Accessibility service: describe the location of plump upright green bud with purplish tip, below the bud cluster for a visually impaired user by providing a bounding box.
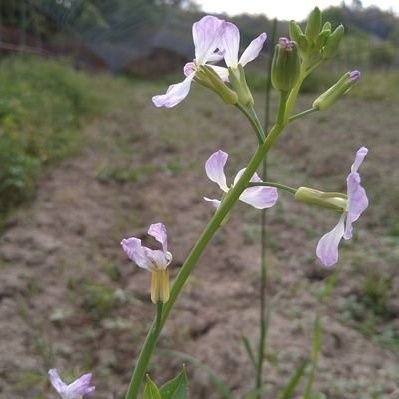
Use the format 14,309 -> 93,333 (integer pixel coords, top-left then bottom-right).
271,37 -> 301,91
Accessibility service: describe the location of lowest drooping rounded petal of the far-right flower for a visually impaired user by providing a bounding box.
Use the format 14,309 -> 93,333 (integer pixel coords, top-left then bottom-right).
316,213 -> 345,266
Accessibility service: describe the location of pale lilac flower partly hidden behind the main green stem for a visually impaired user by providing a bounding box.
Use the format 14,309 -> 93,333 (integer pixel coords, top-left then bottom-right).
204,150 -> 278,209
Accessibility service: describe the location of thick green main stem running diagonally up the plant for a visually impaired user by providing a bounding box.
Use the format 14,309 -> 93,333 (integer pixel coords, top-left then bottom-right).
125,93 -> 287,399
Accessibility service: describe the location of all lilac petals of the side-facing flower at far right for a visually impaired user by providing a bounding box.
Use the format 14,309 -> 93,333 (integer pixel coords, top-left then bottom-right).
316,147 -> 369,266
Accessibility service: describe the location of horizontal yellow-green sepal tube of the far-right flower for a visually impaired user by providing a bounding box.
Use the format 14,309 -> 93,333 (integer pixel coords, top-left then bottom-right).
295,187 -> 348,212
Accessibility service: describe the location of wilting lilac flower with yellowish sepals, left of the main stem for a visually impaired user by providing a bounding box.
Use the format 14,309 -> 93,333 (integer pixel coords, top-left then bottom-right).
121,223 -> 172,304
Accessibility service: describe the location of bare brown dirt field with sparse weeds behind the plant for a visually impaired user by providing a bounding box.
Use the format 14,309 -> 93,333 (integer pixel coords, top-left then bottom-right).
0,79 -> 399,399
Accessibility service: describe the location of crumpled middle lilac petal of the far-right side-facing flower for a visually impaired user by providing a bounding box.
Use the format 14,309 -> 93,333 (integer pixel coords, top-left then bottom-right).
344,172 -> 369,240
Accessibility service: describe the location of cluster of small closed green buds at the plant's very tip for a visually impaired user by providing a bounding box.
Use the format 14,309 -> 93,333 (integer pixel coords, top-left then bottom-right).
289,7 -> 344,60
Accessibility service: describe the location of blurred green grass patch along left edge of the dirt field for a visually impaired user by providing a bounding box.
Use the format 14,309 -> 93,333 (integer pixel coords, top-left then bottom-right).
0,57 -> 101,219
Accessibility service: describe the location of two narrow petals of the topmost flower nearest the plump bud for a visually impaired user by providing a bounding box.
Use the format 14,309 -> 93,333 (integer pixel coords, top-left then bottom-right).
220,22 -> 267,69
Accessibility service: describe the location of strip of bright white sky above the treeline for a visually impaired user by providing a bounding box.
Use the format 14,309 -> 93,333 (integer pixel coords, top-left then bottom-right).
195,0 -> 399,21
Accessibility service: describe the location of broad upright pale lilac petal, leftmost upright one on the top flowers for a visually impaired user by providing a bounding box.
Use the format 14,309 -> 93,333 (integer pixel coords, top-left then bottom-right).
193,15 -> 224,65
